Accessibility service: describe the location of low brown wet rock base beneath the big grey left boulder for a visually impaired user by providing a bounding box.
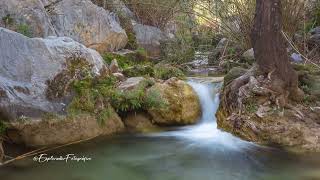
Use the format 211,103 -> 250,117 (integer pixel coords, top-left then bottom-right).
9,112 -> 124,147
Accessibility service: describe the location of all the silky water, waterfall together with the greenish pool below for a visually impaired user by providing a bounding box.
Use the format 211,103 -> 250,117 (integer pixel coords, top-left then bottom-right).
0,80 -> 320,180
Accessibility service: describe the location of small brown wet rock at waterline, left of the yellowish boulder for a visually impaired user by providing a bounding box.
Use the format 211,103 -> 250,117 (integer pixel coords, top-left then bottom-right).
124,112 -> 159,133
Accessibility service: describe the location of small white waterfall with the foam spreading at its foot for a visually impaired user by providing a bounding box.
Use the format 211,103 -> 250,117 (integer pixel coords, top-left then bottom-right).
147,80 -> 253,152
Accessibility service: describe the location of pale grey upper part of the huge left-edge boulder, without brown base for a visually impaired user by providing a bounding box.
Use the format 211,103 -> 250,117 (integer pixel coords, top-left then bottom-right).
0,28 -> 104,119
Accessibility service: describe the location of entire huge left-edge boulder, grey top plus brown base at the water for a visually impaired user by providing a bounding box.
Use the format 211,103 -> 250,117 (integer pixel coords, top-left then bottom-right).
0,28 -> 124,146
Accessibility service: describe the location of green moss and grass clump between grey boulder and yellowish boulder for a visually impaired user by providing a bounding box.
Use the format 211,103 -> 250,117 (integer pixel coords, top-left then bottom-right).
68,76 -> 164,124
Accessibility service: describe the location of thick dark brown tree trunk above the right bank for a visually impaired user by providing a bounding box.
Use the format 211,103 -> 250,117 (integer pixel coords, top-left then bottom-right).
251,0 -> 301,100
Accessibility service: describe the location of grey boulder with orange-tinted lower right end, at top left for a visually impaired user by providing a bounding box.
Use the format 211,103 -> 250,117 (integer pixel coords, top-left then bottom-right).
48,0 -> 128,52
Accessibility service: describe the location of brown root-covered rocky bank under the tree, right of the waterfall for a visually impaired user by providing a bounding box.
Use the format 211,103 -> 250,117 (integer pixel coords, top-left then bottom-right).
216,69 -> 320,152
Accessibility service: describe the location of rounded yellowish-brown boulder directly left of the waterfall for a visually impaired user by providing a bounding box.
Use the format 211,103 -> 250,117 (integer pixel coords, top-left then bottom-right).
148,78 -> 201,125
